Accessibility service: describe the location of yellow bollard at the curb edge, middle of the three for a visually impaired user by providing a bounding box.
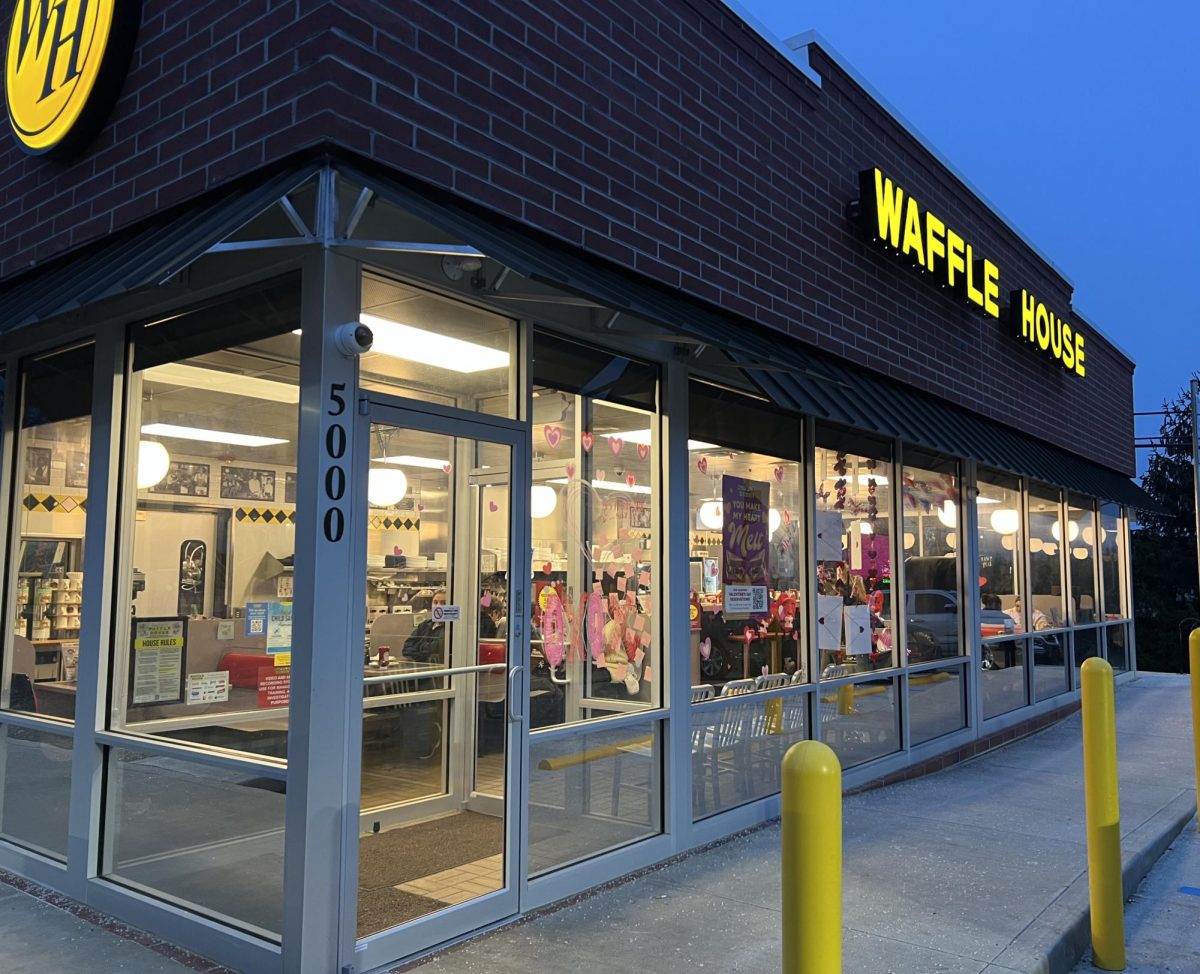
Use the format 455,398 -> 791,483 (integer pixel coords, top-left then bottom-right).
1080,656 -> 1124,970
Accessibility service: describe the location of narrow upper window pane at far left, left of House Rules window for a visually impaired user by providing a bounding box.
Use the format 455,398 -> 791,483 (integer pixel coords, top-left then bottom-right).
0,344 -> 95,719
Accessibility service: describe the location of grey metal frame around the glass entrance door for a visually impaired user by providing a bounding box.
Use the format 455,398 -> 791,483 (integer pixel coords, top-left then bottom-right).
340,391 -> 532,972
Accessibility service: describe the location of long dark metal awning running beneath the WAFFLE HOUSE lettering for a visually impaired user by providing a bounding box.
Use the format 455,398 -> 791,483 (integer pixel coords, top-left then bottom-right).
340,159 -> 1159,511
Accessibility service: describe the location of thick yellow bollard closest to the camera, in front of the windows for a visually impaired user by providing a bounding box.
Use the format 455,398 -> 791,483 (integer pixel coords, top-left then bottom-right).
782,740 -> 841,974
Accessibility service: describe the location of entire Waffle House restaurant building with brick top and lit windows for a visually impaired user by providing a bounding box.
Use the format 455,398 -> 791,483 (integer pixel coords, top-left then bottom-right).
0,0 -> 1144,973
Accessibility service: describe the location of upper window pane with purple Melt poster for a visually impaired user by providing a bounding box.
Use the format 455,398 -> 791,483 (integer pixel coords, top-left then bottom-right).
688,383 -> 808,691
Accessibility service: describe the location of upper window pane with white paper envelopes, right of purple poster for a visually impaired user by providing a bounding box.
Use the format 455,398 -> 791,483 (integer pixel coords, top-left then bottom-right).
812,431 -> 892,679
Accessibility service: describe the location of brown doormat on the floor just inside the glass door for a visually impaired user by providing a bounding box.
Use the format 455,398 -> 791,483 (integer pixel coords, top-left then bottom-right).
359,812 -> 504,892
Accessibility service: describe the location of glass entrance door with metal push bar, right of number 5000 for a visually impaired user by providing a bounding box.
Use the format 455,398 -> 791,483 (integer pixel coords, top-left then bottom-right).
350,403 -> 529,969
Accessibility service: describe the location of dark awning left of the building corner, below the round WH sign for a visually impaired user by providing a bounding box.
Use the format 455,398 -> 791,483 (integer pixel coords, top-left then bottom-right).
0,162 -> 322,335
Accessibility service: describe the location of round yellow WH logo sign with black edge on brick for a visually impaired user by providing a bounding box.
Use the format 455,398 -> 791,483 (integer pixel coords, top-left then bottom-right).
4,0 -> 142,156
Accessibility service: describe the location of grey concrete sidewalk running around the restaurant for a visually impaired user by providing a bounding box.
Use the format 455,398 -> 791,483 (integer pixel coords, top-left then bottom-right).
0,674 -> 1200,974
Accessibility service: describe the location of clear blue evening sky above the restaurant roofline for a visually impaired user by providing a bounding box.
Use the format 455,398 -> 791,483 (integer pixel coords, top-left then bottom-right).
740,0 -> 1200,469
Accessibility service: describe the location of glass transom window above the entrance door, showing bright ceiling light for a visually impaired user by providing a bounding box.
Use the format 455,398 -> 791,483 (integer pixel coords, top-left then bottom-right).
359,273 -> 516,417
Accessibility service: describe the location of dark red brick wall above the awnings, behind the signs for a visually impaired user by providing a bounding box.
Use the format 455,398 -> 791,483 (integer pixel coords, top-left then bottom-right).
0,0 -> 1134,473
